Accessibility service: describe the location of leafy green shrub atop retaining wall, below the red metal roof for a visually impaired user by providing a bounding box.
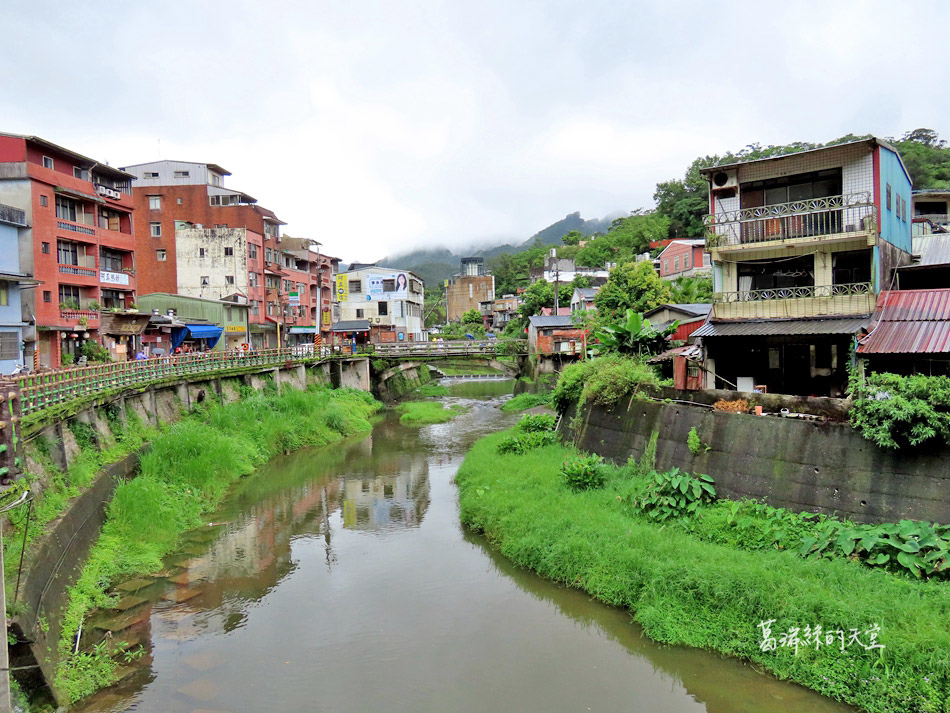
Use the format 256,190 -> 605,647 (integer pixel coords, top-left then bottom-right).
850,374 -> 950,448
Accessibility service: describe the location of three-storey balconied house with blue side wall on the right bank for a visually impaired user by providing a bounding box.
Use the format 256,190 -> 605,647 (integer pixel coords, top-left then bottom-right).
693,138 -> 911,395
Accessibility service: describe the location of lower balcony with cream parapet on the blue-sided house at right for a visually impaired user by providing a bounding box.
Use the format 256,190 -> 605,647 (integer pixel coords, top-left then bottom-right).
712,282 -> 875,320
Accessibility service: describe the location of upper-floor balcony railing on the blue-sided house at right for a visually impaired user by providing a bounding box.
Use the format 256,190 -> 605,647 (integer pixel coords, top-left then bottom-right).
703,191 -> 874,248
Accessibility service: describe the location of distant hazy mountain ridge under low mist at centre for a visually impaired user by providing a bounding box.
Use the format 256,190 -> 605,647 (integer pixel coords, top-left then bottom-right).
377,212 -> 626,286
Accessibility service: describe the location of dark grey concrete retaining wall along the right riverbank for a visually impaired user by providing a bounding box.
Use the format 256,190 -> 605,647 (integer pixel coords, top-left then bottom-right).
561,399 -> 950,523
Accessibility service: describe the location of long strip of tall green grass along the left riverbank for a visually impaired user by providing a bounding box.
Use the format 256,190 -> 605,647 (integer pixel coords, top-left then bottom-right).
56,387 -> 380,702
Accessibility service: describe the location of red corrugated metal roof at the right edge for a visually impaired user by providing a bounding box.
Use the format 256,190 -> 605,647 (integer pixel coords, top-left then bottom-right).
858,289 -> 950,354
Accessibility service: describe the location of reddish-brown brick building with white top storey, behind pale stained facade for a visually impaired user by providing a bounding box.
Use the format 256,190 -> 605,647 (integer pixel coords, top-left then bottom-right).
118,161 -> 284,348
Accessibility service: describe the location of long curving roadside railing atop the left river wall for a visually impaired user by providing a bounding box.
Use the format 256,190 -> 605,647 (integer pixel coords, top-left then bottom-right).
12,344 -> 372,416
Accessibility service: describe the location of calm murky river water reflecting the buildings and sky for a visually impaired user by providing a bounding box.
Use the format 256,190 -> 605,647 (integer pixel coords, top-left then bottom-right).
76,380 -> 851,713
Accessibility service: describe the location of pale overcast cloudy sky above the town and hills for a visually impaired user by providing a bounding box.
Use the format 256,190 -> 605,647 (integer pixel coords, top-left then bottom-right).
0,0 -> 950,261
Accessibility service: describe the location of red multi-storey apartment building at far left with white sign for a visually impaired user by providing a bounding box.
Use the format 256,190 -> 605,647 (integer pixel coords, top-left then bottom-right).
0,134 -> 137,367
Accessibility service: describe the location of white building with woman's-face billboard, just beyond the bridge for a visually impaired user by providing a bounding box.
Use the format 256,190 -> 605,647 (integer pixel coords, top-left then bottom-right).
334,265 -> 425,342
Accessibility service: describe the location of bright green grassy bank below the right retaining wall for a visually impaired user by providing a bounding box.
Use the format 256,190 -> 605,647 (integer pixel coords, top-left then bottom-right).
457,432 -> 950,713
